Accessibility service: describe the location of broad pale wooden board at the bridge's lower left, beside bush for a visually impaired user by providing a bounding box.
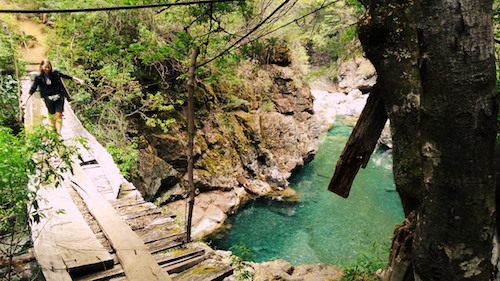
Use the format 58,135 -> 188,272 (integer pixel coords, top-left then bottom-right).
32,179 -> 113,280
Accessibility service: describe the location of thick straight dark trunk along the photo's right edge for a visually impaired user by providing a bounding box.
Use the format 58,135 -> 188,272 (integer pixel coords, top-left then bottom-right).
413,0 -> 497,280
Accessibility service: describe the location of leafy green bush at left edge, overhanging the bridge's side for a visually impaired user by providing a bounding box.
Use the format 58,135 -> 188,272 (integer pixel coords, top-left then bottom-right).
0,126 -> 80,280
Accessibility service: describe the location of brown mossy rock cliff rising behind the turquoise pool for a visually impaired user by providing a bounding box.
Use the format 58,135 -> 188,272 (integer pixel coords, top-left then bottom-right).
133,52 -> 320,236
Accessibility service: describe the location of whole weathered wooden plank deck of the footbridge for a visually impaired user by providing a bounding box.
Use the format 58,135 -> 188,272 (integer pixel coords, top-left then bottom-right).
18,75 -> 232,281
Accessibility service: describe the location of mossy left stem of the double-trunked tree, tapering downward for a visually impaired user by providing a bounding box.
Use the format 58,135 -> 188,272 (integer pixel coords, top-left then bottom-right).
359,0 -> 422,215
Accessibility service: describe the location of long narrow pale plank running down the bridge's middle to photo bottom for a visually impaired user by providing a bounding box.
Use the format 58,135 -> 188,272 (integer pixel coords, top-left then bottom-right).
71,161 -> 171,281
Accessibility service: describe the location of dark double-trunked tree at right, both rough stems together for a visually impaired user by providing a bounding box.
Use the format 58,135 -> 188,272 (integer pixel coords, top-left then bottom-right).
360,0 -> 498,281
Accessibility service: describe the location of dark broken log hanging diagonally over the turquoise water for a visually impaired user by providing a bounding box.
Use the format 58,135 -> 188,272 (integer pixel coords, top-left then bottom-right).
328,85 -> 387,198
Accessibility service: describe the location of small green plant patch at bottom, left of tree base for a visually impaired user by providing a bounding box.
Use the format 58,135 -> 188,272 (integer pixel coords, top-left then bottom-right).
341,243 -> 387,281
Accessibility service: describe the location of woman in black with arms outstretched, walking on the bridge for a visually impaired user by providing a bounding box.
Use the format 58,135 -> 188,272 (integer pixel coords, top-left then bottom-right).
23,59 -> 84,134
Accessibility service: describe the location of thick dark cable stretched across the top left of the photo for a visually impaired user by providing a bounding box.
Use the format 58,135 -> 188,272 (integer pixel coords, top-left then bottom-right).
0,0 -> 242,14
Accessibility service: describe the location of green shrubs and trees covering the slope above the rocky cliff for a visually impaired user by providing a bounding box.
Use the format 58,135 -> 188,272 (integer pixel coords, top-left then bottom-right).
2,0 -> 361,179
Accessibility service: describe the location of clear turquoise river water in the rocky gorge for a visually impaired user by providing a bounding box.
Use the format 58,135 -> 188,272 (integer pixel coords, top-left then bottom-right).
209,118 -> 404,265
